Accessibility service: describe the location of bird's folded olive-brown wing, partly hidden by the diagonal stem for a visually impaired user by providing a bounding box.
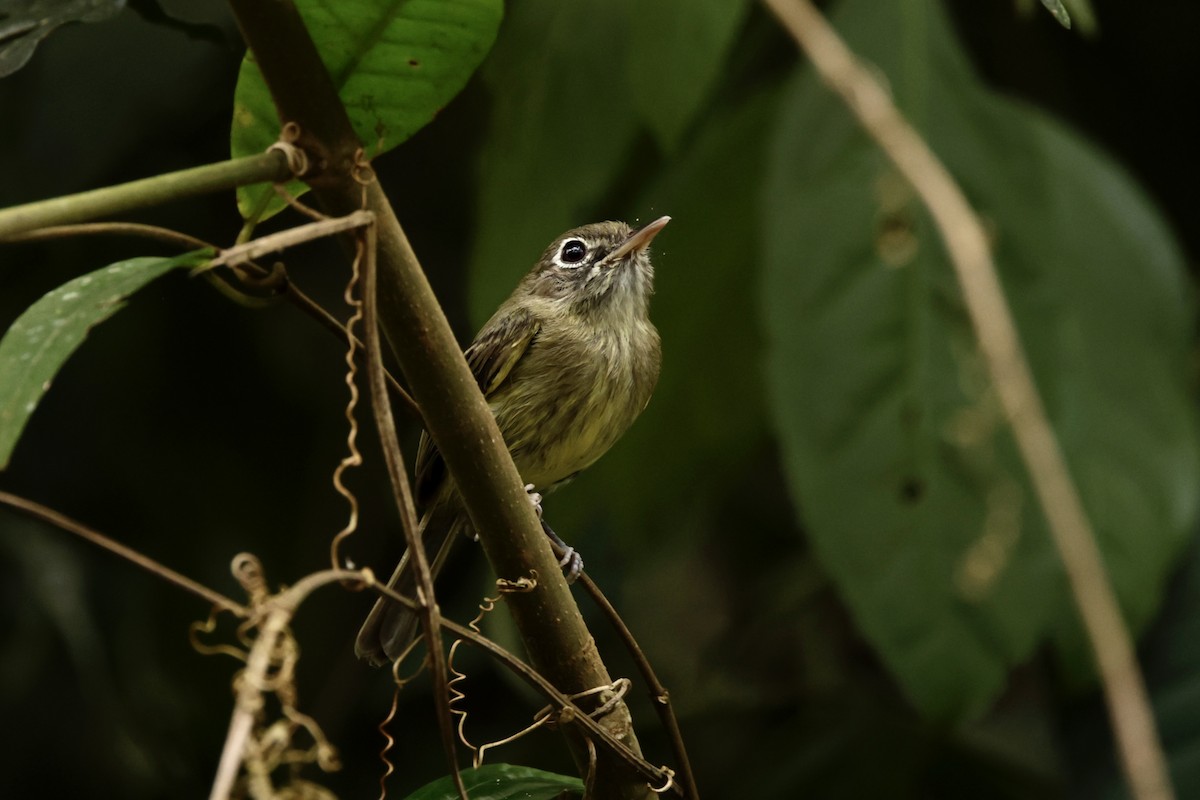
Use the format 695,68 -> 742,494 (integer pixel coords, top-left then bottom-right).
415,308 -> 541,509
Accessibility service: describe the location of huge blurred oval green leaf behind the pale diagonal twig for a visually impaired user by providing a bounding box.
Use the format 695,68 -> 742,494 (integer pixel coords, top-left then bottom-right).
762,0 -> 1200,718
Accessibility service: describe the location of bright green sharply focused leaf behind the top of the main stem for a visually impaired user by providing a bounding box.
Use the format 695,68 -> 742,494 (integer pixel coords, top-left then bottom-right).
230,0 -> 504,218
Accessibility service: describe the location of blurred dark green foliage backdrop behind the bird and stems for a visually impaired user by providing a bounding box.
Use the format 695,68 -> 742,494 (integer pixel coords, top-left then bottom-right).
0,0 -> 1200,798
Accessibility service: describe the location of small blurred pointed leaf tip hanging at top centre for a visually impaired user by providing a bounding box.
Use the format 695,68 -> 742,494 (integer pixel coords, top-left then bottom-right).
628,0 -> 746,151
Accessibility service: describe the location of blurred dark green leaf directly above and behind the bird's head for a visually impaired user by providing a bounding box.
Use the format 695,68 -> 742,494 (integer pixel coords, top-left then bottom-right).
469,0 -> 637,324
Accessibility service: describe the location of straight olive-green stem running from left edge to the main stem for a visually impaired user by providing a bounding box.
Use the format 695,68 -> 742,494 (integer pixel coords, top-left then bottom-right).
0,150 -> 292,240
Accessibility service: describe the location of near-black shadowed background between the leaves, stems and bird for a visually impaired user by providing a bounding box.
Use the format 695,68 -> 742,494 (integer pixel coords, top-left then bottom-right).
0,0 -> 1200,798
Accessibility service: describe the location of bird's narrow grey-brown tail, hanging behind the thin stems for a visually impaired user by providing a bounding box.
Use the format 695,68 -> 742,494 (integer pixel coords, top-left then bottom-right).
354,504 -> 463,667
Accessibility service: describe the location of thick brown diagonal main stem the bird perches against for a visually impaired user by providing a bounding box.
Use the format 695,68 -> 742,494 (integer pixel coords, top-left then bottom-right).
230,0 -> 647,798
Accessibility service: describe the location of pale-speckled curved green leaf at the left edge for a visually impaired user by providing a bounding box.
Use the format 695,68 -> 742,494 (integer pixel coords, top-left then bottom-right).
0,251 -> 212,469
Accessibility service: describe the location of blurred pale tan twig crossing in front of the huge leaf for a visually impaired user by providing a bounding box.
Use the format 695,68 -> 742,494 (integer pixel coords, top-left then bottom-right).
764,0 -> 1174,800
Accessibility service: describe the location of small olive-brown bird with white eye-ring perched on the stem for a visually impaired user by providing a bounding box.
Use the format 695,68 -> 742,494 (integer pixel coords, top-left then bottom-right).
354,217 -> 671,664
